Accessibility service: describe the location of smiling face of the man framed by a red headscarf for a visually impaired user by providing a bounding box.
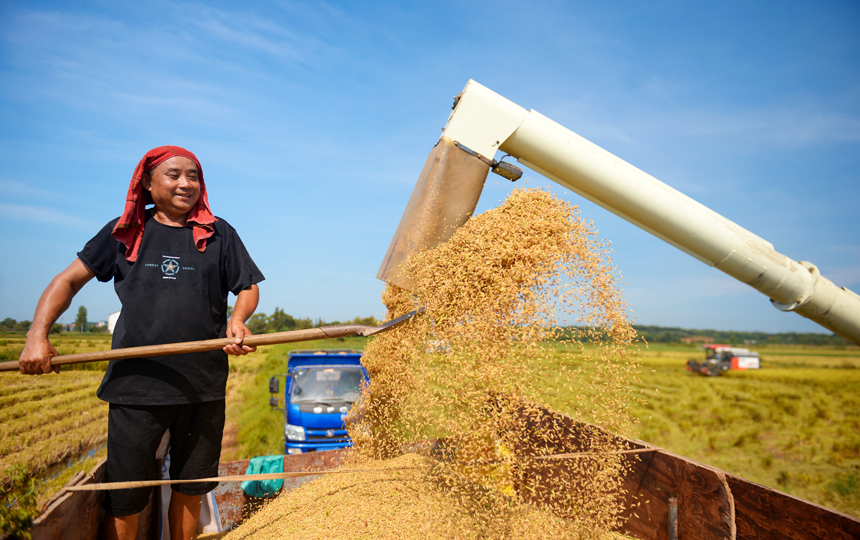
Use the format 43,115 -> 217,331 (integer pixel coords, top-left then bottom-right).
142,156 -> 200,216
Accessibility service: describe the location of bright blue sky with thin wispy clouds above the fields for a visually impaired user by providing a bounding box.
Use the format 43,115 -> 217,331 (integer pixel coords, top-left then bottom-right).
0,0 -> 860,332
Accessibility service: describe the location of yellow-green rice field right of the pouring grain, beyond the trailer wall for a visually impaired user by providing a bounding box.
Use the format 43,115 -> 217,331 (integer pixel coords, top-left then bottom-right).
634,347 -> 860,517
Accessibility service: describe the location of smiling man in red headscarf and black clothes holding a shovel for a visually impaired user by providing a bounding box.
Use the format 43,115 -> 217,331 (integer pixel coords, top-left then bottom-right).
19,146 -> 263,540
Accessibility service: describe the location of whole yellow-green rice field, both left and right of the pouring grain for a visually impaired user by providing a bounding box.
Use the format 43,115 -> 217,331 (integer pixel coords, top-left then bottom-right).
0,334 -> 860,517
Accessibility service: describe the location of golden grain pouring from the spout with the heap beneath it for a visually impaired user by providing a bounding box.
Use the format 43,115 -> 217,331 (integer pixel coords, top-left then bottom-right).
228,189 -> 637,539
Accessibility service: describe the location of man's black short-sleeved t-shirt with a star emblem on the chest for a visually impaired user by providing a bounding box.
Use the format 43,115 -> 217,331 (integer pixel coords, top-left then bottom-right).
78,213 -> 264,405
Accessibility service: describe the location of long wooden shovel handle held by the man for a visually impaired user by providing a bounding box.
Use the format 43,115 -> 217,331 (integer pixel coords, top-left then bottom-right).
0,324 -> 374,372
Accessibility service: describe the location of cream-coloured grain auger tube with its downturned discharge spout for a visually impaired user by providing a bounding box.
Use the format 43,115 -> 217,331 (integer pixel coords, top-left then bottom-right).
377,81 -> 860,345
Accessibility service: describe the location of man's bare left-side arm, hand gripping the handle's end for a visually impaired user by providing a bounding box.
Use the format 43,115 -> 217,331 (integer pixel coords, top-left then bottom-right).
18,259 -> 95,375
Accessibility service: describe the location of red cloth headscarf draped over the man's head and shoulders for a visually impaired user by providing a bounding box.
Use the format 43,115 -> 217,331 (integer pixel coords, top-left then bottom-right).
111,146 -> 217,262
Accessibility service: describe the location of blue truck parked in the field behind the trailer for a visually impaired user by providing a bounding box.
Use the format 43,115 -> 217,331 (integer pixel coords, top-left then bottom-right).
269,349 -> 370,454
